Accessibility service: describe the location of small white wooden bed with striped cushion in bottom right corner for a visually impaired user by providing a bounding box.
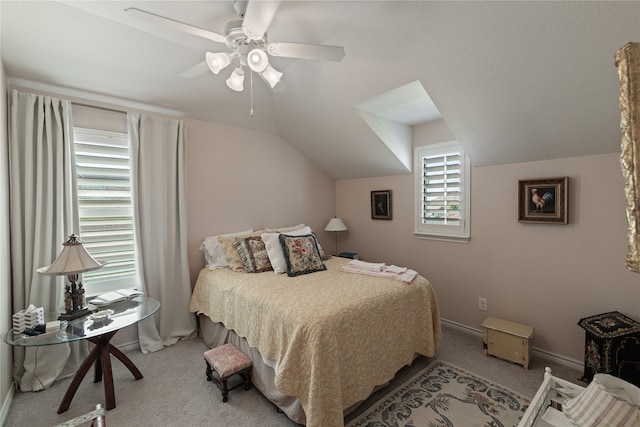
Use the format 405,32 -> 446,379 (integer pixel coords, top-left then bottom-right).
518,368 -> 640,427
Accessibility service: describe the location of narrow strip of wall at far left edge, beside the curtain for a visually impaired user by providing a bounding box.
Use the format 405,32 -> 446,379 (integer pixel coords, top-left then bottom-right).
0,63 -> 13,425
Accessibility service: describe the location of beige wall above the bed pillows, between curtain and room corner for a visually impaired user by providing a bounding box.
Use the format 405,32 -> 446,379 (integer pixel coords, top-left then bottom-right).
186,117 -> 335,283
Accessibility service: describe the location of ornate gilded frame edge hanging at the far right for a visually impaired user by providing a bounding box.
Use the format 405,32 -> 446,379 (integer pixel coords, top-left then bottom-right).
616,43 -> 640,273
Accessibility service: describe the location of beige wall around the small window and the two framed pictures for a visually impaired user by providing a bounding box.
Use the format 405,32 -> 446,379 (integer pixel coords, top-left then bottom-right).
336,122 -> 640,362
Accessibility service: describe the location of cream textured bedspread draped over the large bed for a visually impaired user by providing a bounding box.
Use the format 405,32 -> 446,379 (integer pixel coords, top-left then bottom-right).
190,258 -> 441,427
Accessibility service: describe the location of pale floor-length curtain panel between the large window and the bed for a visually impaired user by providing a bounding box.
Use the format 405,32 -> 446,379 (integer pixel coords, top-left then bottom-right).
128,113 -> 196,353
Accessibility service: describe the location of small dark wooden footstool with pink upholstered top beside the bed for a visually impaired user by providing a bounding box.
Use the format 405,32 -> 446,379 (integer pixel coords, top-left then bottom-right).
204,344 -> 251,402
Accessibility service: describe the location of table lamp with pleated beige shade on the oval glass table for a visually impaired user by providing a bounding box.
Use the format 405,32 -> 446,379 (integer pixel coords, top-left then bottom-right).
37,234 -> 104,320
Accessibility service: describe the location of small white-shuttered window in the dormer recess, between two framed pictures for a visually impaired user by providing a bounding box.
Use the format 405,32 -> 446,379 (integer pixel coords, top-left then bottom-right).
414,142 -> 470,242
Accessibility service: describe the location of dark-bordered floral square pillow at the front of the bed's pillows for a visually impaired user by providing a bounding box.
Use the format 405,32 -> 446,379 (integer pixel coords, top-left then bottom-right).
278,234 -> 327,277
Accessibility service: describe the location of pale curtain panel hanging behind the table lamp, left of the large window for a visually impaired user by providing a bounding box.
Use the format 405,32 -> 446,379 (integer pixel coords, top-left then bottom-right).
9,89 -> 87,391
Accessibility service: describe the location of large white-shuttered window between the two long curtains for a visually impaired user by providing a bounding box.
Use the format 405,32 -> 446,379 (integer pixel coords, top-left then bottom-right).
74,128 -> 137,295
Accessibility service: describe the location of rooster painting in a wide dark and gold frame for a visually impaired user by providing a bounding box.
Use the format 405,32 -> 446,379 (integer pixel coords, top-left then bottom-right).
518,176 -> 569,224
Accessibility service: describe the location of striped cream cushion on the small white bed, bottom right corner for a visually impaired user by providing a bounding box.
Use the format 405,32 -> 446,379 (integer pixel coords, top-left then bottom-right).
562,381 -> 640,427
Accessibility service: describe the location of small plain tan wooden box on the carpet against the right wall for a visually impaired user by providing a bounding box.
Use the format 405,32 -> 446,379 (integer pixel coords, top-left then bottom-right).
482,317 -> 533,369
